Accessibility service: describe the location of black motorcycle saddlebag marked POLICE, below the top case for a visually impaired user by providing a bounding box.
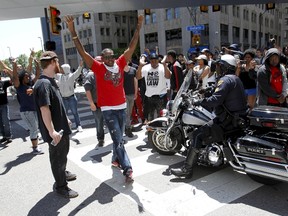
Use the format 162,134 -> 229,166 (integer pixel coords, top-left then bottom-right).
233,135 -> 288,163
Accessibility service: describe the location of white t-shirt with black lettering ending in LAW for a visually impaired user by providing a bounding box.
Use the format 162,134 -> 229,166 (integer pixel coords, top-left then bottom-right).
141,64 -> 167,97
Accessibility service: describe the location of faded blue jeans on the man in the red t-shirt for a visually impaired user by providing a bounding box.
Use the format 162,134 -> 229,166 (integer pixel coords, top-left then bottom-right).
102,109 -> 132,175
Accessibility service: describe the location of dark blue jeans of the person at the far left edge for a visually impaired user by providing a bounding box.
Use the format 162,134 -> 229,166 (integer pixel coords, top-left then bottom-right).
0,104 -> 12,138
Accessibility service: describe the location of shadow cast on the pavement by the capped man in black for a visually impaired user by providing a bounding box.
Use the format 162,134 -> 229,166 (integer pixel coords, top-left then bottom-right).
28,192 -> 70,216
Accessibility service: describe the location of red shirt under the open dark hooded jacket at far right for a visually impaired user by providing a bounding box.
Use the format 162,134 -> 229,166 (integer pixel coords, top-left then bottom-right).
268,66 -> 283,104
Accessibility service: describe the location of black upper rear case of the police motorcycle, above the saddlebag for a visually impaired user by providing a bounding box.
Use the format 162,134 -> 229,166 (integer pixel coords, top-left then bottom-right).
248,106 -> 288,132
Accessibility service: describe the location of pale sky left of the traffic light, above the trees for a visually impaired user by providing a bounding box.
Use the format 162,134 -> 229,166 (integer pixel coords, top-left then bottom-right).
0,18 -> 44,60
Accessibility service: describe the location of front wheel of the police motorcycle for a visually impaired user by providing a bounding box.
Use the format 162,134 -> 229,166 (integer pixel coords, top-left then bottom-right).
148,129 -> 182,155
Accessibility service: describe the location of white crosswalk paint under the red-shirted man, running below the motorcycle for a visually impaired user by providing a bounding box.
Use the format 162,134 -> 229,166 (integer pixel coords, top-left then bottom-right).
69,125 -> 262,216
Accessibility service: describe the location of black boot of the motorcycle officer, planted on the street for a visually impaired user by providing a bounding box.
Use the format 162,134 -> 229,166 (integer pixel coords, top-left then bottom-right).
171,148 -> 198,179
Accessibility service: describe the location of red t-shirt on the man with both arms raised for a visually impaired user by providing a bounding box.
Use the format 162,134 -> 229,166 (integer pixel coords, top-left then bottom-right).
91,55 -> 127,107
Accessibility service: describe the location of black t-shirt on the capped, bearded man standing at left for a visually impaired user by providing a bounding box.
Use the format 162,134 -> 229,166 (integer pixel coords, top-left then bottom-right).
33,75 -> 71,143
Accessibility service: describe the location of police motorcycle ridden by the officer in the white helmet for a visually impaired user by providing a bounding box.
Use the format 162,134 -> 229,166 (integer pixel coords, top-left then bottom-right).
148,55 -> 288,184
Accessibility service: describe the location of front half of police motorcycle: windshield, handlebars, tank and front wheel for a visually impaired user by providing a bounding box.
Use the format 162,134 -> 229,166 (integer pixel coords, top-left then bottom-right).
146,70 -> 214,155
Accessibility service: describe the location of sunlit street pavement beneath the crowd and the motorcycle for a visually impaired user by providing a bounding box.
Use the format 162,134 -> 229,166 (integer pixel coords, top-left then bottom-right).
0,87 -> 288,216
